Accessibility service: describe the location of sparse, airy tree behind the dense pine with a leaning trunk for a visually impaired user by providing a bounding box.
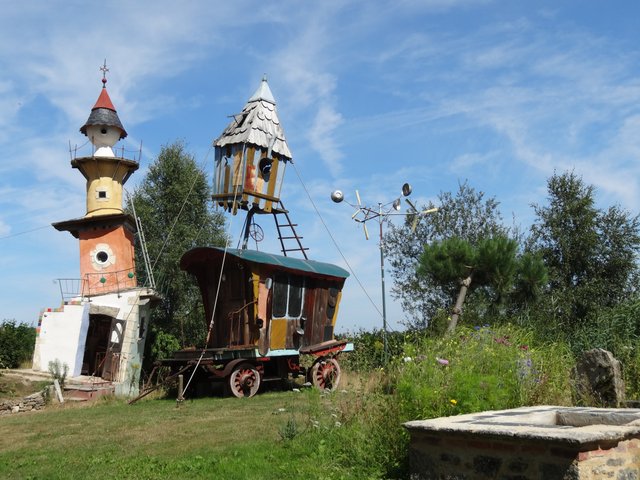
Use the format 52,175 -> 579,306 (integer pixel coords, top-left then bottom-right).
384,181 -> 508,328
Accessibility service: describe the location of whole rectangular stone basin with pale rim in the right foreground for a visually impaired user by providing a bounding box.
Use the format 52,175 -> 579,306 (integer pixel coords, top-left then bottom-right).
405,406 -> 640,480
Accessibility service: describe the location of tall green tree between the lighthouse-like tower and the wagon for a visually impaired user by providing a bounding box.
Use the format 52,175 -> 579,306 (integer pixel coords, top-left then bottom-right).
127,142 -> 227,358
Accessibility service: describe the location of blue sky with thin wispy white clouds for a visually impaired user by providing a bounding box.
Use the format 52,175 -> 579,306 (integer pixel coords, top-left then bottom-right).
0,0 -> 640,330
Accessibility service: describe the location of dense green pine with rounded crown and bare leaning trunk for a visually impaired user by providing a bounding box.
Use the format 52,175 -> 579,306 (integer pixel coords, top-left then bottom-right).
417,235 -> 547,333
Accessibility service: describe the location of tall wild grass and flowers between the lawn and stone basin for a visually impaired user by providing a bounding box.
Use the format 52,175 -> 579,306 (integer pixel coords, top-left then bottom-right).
316,325 -> 573,478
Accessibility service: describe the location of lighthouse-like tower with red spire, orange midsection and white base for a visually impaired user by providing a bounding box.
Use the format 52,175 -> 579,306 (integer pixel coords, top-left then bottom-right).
33,65 -> 158,395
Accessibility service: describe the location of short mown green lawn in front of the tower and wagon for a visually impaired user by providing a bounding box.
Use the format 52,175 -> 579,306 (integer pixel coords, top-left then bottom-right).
0,391 -> 352,479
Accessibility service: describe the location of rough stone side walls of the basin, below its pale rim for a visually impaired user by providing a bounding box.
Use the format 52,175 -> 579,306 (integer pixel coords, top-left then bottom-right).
410,432 -> 640,480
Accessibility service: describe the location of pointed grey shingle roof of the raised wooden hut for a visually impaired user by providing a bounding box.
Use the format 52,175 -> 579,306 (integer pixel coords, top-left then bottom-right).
218,76 -> 292,160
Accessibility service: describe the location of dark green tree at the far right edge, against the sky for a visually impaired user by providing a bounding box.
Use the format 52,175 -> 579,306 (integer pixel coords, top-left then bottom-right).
529,172 -> 640,332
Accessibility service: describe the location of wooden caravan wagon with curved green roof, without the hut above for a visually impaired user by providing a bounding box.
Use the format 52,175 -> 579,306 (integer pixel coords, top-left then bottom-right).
161,247 -> 353,397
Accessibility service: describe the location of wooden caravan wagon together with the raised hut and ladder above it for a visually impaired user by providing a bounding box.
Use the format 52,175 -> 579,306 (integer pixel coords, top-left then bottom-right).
133,77 -> 353,397
